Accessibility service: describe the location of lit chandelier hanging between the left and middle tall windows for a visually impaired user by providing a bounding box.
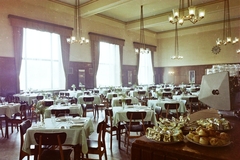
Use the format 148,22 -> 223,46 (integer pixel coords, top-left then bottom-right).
67,0 -> 89,44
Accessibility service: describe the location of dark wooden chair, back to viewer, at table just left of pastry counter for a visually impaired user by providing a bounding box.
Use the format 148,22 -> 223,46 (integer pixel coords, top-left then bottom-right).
125,112 -> 146,154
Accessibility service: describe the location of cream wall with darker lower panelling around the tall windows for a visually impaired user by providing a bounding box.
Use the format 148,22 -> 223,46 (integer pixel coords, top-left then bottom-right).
0,0 -> 240,95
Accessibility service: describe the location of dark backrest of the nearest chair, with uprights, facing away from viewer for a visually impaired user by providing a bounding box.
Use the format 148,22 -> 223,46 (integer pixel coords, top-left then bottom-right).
34,132 -> 67,160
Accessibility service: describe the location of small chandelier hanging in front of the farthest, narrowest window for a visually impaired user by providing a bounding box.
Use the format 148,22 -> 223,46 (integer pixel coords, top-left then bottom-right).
135,5 -> 150,54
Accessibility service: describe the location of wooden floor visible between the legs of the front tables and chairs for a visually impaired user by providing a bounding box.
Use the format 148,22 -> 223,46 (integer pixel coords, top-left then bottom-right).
0,111 -> 130,160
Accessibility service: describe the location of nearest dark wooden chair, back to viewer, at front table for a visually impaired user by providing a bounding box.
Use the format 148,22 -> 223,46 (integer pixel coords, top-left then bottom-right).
34,132 -> 72,160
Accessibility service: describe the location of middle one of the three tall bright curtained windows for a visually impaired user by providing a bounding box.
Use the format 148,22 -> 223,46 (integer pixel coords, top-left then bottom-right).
96,42 -> 121,87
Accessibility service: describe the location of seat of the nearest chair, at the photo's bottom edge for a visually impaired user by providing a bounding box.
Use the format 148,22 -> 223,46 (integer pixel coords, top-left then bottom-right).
41,149 -> 72,160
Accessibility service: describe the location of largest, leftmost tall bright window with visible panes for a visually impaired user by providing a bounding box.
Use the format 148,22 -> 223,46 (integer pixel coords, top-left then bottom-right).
19,28 -> 66,90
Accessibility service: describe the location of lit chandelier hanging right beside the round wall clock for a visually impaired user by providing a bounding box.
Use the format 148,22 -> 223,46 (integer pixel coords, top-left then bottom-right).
216,0 -> 239,46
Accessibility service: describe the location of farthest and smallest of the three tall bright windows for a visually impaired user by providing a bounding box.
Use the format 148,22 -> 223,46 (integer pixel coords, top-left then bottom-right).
138,53 -> 154,85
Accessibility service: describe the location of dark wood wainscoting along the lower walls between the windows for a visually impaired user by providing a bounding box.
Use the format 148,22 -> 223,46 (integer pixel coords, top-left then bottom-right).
0,57 -> 237,96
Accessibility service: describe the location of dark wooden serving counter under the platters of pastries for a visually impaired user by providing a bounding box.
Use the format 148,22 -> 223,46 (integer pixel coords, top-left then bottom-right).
131,112 -> 240,160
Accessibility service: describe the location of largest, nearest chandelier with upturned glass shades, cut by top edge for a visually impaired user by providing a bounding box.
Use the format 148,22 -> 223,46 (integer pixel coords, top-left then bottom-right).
168,0 -> 205,25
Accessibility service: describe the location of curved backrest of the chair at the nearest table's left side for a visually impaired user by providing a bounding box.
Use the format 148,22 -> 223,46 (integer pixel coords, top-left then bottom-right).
19,119 -> 32,159
